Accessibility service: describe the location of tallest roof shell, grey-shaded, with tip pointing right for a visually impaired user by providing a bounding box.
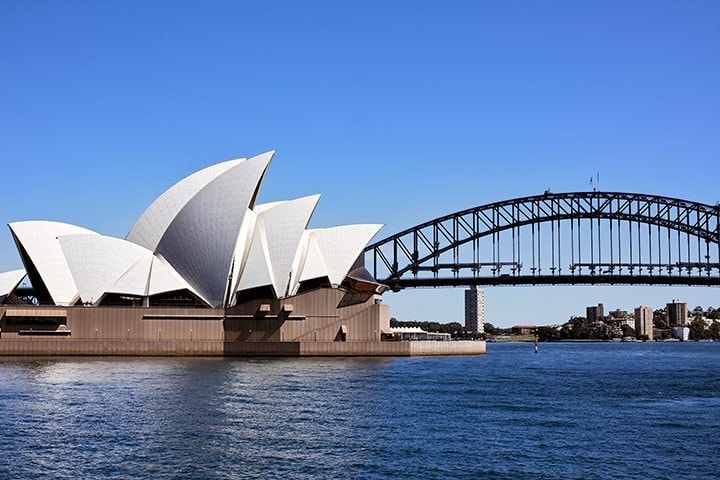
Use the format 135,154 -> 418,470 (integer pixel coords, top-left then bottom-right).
155,152 -> 274,305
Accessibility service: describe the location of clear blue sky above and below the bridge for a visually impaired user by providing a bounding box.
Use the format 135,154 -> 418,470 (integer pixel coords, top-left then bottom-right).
0,0 -> 720,326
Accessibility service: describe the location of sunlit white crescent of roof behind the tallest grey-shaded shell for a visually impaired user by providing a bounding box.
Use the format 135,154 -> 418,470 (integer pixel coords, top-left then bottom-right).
125,158 -> 245,251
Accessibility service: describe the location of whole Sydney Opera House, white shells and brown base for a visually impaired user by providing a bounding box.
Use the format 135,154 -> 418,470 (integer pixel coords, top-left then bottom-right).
0,152 -> 484,355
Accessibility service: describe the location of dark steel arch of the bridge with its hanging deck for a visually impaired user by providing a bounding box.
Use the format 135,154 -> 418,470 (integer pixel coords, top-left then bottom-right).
365,191 -> 720,291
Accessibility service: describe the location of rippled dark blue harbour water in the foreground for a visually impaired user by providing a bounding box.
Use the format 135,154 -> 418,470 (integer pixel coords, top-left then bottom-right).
0,343 -> 720,479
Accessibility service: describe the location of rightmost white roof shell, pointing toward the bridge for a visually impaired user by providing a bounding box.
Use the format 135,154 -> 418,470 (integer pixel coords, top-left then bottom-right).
300,224 -> 382,287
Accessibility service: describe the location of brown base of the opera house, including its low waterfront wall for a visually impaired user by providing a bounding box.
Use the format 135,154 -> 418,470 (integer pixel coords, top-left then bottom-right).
0,288 -> 485,356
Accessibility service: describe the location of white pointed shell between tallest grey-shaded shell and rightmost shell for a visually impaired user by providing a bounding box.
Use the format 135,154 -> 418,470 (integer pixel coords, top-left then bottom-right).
238,195 -> 320,298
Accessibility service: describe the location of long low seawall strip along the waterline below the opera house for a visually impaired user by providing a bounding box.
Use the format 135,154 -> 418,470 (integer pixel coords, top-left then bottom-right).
0,338 -> 485,357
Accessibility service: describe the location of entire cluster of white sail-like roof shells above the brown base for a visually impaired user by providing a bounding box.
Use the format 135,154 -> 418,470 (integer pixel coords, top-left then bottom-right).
5,151 -> 381,306
